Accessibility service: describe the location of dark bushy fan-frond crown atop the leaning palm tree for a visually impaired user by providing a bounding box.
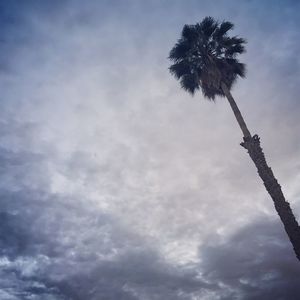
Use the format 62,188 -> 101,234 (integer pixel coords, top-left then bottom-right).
169,17 -> 246,100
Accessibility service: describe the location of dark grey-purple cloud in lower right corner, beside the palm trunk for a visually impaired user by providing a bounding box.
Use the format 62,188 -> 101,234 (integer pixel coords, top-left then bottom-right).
200,218 -> 300,300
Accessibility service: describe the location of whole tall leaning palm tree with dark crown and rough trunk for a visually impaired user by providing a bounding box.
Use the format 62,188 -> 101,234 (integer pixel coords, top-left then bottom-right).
169,17 -> 300,260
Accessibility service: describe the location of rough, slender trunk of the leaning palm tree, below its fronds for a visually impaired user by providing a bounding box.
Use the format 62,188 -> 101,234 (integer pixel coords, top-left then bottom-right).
222,83 -> 300,260
